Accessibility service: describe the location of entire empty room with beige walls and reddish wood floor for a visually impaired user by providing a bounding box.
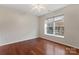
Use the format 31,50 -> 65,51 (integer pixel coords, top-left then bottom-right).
0,4 -> 79,55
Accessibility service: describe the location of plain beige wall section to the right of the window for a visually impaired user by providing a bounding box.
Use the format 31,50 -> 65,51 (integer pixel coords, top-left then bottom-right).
64,5 -> 79,48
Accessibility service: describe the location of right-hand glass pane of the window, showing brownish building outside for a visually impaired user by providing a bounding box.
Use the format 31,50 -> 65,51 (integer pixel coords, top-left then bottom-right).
55,19 -> 64,36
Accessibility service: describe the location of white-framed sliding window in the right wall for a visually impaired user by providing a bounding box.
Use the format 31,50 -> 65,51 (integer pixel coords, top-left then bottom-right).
45,15 -> 64,37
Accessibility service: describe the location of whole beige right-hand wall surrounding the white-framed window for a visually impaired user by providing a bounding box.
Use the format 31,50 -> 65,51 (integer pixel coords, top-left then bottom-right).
39,5 -> 79,48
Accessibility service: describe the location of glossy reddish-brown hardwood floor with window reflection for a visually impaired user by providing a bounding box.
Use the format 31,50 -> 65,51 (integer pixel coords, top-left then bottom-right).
0,38 -> 79,55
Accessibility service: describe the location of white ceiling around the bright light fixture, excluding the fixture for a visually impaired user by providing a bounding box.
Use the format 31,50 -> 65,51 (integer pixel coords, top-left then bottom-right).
0,4 -> 67,16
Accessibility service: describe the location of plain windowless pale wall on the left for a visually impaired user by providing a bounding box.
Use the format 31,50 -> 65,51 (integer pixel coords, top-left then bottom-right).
0,7 -> 38,45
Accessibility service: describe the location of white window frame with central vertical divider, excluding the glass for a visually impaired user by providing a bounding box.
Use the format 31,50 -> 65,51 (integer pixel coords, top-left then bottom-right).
44,14 -> 64,38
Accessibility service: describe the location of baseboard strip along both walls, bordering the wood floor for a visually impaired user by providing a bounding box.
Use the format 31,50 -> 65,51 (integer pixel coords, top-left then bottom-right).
0,36 -> 79,49
